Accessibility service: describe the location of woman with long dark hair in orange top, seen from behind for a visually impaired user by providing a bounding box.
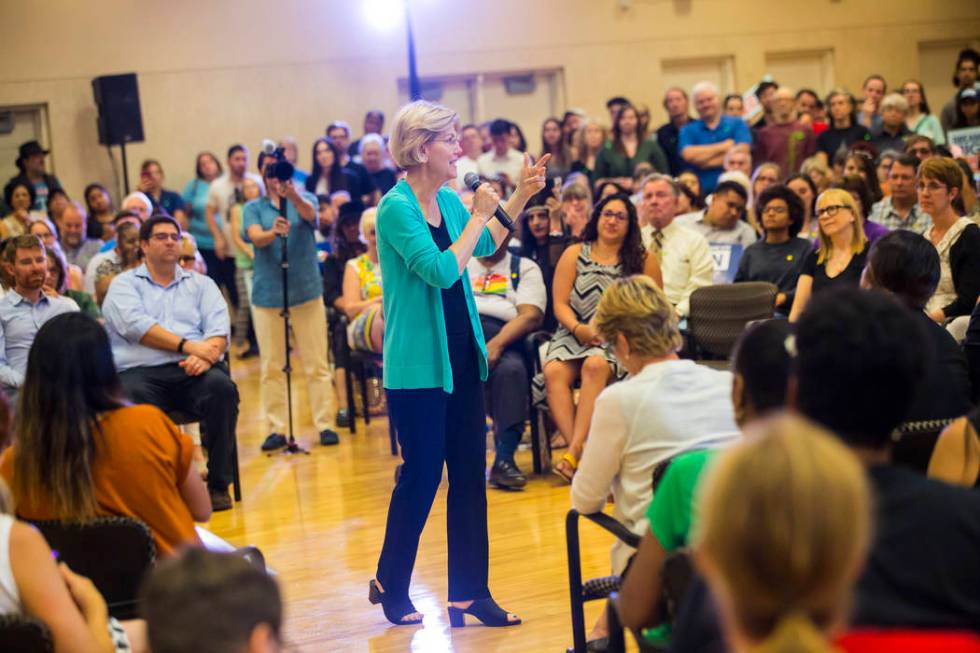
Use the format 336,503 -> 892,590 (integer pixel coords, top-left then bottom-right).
0,313 -> 211,555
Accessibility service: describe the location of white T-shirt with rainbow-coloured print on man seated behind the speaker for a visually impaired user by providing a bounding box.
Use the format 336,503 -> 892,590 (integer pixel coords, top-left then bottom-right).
466,252 -> 548,322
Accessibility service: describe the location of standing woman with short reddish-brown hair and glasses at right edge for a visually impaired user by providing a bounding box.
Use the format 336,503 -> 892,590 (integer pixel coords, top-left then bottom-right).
918,157 -> 980,340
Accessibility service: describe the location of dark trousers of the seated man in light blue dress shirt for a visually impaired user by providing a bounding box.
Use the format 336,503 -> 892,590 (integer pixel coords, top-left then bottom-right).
119,362 -> 238,492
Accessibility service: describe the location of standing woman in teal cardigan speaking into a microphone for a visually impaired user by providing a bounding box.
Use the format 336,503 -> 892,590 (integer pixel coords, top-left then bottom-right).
369,101 -> 550,627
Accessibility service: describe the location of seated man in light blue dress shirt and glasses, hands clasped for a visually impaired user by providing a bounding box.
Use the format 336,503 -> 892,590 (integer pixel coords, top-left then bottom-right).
102,215 -> 238,510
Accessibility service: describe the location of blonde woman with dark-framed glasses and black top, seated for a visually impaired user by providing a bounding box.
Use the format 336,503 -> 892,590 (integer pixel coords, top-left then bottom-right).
789,188 -> 868,322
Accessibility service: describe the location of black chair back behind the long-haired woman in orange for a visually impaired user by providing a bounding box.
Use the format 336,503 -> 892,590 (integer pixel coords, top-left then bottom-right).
32,517 -> 156,620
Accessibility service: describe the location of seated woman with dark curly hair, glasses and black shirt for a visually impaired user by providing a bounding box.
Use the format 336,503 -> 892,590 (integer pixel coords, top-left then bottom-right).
735,185 -> 813,315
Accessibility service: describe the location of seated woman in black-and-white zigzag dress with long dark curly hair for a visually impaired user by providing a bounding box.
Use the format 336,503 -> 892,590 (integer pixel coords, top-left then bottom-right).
544,194 -> 663,480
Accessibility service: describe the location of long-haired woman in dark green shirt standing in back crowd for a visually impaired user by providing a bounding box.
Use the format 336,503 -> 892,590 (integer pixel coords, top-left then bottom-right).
595,105 -> 670,190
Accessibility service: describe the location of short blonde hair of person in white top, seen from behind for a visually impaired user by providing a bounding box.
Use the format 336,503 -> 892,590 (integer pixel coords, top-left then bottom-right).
594,274 -> 683,356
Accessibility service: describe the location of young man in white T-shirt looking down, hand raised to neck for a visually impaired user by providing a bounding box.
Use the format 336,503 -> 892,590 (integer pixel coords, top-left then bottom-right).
678,181 -> 758,284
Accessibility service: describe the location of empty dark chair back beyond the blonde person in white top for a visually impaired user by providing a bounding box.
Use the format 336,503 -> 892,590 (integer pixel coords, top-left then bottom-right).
687,281 -> 778,367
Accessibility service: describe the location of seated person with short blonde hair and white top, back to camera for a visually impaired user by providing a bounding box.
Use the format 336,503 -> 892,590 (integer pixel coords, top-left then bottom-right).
572,276 -> 739,639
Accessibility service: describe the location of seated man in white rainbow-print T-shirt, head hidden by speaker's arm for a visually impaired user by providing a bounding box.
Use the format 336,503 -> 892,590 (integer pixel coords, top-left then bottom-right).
466,238 -> 548,490
